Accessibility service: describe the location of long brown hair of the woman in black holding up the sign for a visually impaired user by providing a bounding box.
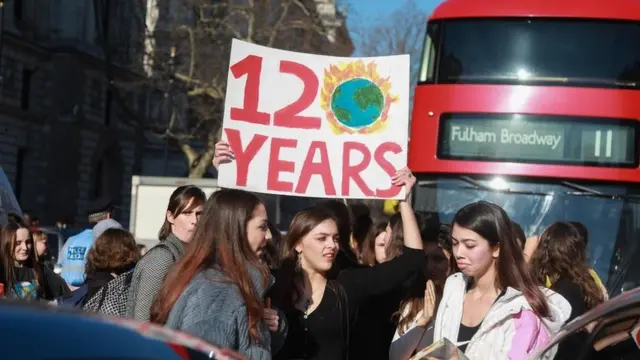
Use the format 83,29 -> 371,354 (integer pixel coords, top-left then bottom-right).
272,206 -> 342,310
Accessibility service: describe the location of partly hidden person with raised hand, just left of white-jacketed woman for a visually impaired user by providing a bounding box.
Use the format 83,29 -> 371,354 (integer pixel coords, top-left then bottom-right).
389,225 -> 454,360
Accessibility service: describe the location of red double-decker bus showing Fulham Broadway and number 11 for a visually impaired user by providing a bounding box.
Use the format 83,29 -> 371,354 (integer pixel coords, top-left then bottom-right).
409,0 -> 640,295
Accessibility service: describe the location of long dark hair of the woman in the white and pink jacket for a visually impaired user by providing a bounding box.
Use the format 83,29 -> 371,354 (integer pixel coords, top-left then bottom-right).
453,201 -> 549,317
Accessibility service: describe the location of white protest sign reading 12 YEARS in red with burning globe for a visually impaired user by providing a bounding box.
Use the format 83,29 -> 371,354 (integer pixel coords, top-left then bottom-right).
218,40 -> 409,199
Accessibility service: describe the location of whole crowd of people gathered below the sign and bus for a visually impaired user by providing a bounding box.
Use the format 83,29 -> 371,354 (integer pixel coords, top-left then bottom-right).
0,143 -> 607,360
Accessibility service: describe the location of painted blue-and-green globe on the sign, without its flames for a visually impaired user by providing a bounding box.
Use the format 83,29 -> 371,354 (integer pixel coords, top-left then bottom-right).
331,78 -> 384,128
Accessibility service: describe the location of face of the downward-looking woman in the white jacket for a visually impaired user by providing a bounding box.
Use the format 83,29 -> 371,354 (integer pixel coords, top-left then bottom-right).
451,224 -> 500,278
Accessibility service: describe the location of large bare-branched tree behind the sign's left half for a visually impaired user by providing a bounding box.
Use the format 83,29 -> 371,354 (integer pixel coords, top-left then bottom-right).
101,0 -> 350,177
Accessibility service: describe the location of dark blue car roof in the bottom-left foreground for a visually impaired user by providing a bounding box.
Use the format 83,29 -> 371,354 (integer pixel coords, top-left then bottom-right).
0,300 -> 235,359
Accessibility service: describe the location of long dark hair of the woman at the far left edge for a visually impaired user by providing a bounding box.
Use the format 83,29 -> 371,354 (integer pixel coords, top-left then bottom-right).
0,222 -> 50,298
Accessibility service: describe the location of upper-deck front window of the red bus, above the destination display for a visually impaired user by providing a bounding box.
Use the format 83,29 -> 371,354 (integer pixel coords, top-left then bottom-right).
421,18 -> 640,89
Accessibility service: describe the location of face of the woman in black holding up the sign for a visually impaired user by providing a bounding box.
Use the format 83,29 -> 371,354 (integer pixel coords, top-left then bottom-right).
295,220 -> 340,273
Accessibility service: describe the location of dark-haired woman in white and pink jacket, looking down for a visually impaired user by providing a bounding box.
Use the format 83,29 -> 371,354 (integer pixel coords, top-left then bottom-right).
434,201 -> 571,360
